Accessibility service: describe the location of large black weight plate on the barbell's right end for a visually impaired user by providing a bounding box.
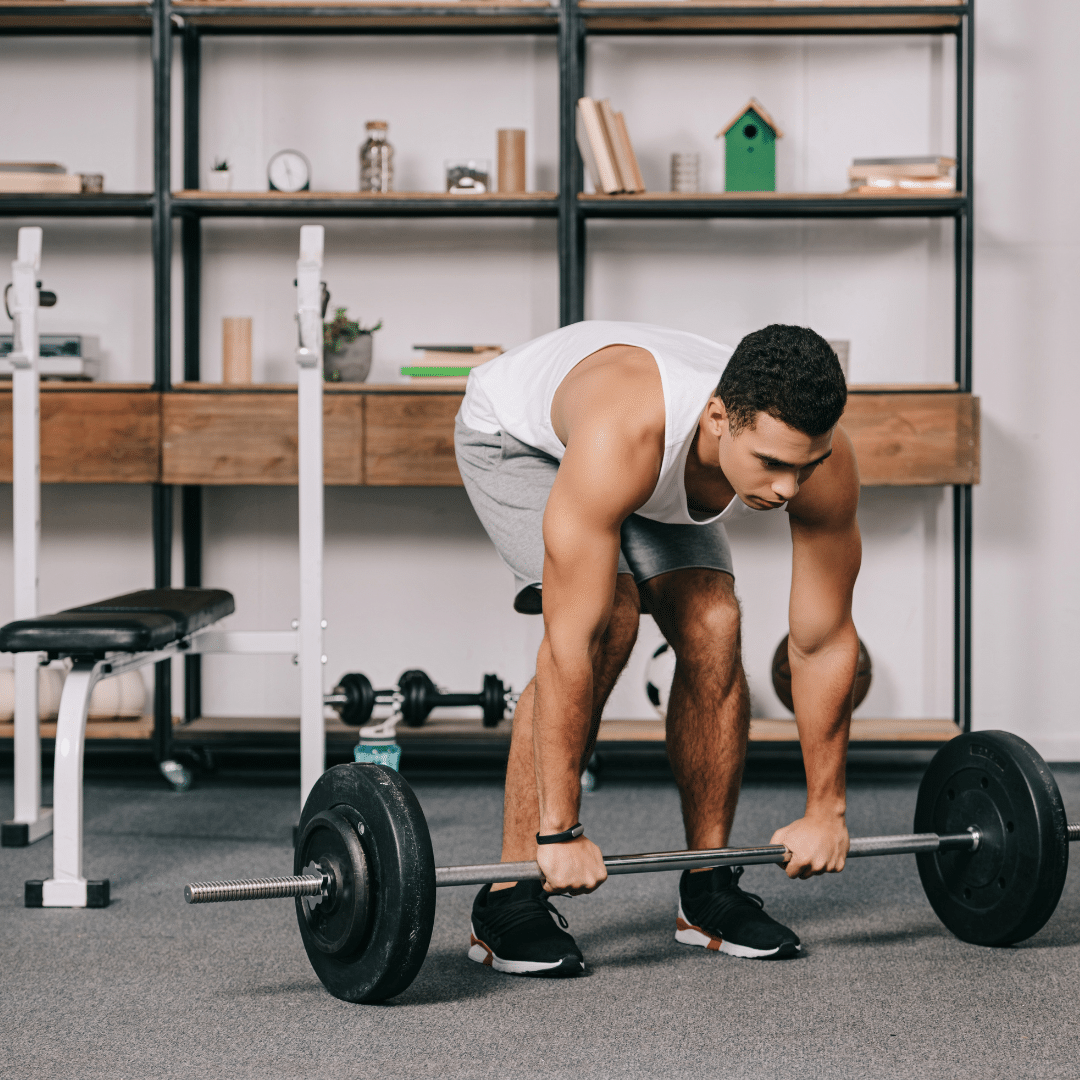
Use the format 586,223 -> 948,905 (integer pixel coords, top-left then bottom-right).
915,731 -> 1069,945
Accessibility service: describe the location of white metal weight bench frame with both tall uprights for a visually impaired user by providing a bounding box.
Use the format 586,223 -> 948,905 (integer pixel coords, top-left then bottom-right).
4,225 -> 326,907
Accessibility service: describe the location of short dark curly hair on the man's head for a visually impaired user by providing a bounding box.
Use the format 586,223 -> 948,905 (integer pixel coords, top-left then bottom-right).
716,323 -> 848,436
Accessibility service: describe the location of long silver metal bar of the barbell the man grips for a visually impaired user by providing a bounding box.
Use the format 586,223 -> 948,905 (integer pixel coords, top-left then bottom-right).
184,823 -> 989,904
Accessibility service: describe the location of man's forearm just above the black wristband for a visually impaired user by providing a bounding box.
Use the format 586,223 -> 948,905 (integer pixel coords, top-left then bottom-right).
532,638 -> 593,833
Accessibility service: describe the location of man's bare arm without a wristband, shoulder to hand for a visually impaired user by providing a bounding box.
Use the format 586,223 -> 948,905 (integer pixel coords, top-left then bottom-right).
775,428 -> 862,877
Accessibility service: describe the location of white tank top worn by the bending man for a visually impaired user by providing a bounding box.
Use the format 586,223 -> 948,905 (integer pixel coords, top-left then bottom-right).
458,321 -> 758,525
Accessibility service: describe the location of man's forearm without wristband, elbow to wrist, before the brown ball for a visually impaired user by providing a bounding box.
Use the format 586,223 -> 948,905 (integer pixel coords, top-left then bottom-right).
789,625 -> 859,816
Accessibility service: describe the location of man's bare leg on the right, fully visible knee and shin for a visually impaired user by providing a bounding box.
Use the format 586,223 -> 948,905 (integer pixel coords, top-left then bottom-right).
642,568 -> 750,848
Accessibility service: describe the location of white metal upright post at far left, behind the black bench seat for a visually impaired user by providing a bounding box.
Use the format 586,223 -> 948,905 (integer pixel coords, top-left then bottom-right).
4,227 -> 53,846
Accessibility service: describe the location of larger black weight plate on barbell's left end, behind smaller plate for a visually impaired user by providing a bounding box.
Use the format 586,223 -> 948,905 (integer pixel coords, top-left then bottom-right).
293,764 -> 435,1003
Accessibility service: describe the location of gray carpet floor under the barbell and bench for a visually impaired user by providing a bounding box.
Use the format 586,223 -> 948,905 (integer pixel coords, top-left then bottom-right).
0,769 -> 1080,1080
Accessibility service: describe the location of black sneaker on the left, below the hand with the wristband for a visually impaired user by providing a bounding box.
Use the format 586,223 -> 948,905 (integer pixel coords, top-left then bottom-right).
469,881 -> 585,978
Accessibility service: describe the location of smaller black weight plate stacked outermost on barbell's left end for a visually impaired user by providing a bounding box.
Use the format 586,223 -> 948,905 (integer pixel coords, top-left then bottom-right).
295,806 -> 370,956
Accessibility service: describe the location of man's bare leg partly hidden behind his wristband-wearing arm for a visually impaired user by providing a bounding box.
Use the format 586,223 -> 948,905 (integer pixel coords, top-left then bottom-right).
491,573 -> 640,872
